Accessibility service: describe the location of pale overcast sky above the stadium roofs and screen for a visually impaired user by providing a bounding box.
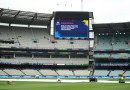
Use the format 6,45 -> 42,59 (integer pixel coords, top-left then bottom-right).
0,0 -> 130,23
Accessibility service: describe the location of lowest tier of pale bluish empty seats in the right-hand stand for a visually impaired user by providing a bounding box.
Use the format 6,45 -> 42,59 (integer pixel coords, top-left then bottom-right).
94,70 -> 130,76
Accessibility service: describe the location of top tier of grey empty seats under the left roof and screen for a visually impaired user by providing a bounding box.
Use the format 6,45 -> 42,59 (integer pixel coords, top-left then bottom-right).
0,26 -> 89,48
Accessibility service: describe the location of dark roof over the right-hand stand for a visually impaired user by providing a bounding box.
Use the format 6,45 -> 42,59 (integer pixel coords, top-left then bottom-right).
92,22 -> 130,34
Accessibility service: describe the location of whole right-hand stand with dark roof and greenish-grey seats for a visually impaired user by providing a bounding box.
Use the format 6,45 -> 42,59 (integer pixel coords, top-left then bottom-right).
93,22 -> 130,77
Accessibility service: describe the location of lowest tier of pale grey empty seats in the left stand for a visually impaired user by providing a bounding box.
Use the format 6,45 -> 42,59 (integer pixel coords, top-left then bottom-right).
0,69 -> 90,76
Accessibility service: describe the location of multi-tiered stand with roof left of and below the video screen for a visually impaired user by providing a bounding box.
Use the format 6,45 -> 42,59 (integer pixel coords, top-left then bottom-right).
0,8 -> 93,77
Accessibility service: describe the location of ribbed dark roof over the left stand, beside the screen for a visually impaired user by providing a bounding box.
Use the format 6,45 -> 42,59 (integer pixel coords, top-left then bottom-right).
0,8 -> 52,25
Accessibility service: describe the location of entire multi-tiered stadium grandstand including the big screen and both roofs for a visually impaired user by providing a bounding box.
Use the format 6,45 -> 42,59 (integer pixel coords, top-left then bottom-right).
0,8 -> 130,78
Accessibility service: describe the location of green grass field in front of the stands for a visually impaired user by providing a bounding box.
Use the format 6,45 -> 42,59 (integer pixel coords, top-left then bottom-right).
0,81 -> 130,90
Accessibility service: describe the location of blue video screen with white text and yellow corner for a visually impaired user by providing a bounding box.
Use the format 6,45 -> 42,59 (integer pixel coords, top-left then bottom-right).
54,19 -> 89,38
